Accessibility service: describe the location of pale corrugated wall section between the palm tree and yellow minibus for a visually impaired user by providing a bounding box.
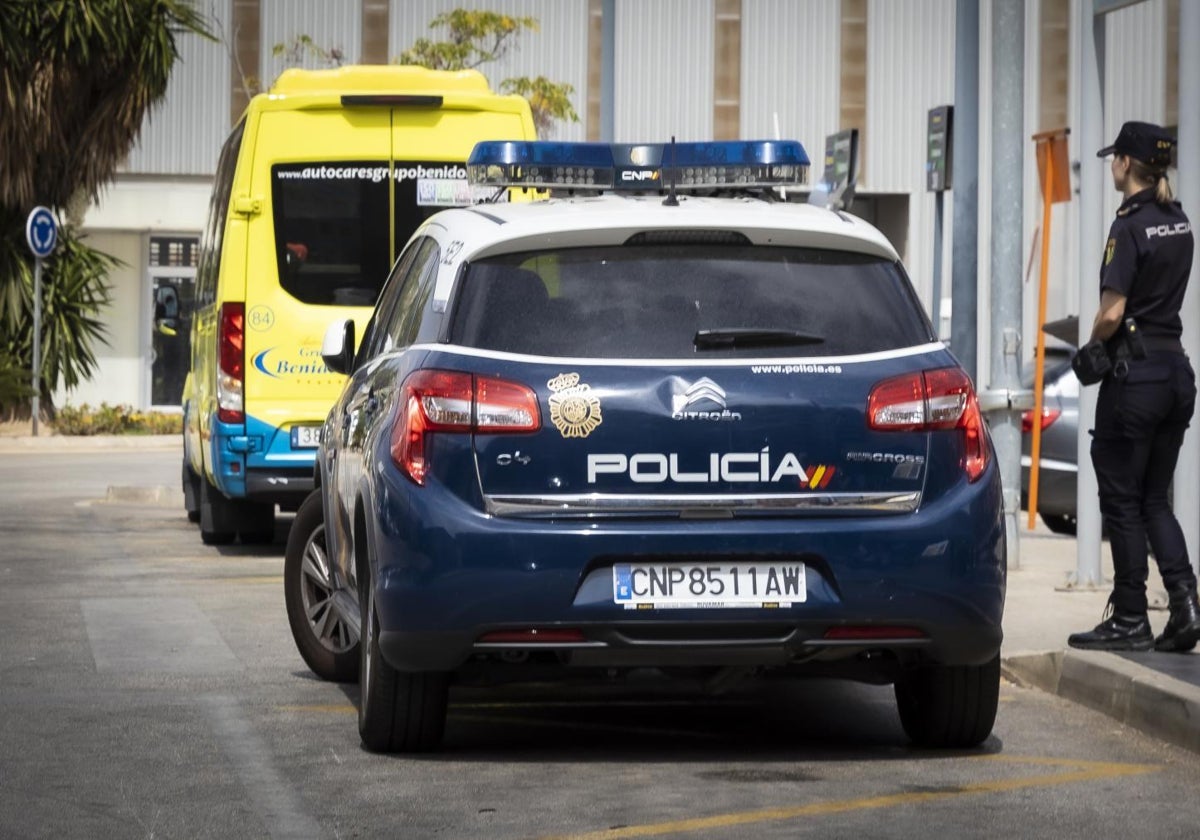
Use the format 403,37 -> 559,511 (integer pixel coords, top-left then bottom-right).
120,0 -> 232,175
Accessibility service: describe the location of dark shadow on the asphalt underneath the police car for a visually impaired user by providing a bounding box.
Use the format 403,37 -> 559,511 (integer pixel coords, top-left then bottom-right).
340,679 -> 1003,763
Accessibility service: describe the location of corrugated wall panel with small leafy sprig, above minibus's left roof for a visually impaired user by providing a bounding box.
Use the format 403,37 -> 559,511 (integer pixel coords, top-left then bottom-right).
258,0 -> 362,90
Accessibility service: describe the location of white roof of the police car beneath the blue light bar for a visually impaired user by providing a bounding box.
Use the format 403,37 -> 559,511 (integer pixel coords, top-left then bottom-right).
414,193 -> 899,301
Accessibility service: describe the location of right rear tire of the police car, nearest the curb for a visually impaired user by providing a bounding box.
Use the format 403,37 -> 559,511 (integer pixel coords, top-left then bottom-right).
895,654 -> 1000,749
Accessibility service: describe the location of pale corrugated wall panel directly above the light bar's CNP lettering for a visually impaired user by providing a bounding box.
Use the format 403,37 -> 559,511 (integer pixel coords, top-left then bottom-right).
613,0 -> 710,143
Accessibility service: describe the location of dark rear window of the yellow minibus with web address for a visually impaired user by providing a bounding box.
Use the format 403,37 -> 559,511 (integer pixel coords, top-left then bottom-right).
271,161 -> 470,306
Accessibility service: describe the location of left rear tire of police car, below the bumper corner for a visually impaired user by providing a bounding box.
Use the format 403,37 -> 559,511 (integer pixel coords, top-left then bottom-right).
359,573 -> 449,752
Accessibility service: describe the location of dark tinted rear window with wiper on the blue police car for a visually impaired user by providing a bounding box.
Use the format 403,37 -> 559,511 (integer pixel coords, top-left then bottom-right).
451,245 -> 935,359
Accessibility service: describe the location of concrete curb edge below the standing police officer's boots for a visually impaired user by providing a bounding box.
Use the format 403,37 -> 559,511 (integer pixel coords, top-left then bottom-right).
1001,650 -> 1200,752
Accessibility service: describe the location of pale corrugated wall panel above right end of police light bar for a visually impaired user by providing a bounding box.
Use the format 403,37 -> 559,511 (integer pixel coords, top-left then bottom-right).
742,0 -> 841,157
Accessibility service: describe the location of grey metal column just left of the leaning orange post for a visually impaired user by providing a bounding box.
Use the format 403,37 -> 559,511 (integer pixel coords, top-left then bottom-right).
984,0 -> 1027,569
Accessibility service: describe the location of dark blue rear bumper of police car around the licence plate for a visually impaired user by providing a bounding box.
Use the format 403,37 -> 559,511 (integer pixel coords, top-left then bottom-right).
367,466 -> 1006,671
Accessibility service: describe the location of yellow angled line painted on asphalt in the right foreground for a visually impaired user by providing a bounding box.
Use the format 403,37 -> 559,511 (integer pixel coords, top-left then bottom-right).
542,756 -> 1162,840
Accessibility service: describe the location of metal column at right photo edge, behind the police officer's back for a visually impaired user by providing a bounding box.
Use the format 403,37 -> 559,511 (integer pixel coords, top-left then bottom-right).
1175,1 -> 1200,569
